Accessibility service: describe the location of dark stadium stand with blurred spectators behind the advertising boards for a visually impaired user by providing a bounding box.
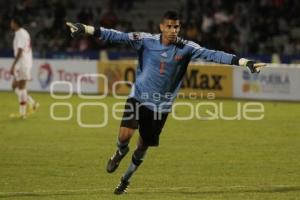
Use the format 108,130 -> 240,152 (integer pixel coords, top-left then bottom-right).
0,0 -> 300,55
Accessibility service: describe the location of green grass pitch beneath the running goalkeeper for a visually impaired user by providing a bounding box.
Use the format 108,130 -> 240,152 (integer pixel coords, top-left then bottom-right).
0,92 -> 300,200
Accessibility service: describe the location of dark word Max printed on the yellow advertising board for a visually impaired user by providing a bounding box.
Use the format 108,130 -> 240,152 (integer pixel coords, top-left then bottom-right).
181,70 -> 224,90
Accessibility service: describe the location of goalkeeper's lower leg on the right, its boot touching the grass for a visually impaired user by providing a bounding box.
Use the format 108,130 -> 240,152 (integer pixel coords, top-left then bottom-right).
114,136 -> 149,194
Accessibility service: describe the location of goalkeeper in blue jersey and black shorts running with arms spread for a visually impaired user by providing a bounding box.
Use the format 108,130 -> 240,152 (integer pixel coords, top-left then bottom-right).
67,11 -> 265,194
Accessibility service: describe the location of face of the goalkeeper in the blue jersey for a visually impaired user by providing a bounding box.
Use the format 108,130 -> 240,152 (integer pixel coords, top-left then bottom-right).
160,19 -> 180,43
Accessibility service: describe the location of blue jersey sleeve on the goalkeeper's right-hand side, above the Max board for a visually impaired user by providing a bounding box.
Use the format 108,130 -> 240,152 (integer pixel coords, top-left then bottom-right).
187,42 -> 235,65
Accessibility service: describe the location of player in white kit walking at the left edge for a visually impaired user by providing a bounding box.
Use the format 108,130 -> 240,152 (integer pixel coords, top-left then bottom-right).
10,17 -> 39,119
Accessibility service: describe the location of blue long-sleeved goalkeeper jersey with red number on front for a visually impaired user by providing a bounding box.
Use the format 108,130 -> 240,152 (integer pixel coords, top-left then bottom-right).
96,27 -> 234,113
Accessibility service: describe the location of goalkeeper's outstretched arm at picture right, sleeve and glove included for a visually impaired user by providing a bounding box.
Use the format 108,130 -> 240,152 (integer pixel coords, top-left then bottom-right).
187,42 -> 266,73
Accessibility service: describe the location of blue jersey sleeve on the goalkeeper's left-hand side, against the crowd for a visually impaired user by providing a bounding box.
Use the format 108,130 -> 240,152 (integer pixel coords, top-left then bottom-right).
96,27 -> 144,50
